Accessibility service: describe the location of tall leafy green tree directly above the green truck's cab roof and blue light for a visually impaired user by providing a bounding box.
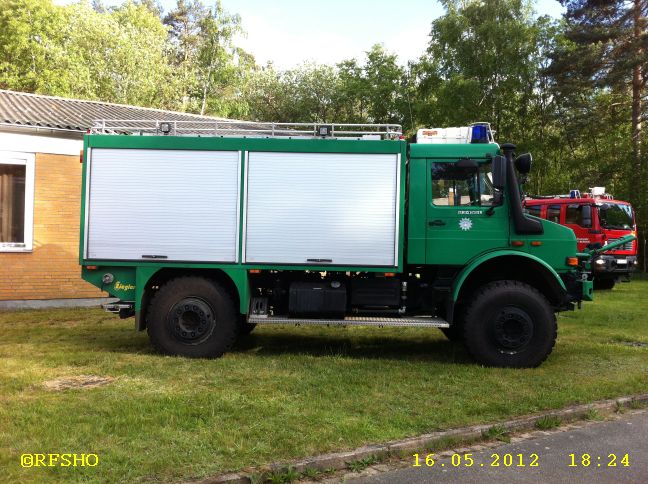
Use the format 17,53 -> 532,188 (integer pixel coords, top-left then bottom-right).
416,0 -> 541,139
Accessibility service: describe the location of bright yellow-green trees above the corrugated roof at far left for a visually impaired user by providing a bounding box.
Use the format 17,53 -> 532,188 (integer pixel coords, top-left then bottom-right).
0,0 -> 175,106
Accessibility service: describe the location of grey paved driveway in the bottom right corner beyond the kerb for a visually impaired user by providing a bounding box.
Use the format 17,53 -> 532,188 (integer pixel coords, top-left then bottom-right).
347,410 -> 648,484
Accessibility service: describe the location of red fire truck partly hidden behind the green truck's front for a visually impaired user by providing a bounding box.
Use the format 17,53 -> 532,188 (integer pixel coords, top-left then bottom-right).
524,187 -> 637,289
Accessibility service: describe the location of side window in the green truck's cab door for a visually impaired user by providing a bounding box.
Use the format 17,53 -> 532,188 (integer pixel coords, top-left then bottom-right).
432,163 -> 497,207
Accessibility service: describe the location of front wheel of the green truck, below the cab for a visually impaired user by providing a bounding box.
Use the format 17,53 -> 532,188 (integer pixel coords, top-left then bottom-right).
464,281 -> 558,368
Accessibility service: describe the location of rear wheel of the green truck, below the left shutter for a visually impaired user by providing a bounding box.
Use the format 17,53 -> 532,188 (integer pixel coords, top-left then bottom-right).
147,277 -> 238,358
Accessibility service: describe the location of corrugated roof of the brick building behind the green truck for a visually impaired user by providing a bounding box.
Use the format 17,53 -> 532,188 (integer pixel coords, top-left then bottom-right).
0,89 -> 238,132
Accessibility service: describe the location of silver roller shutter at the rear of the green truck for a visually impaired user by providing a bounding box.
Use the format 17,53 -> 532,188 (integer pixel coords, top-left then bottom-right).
86,148 -> 241,262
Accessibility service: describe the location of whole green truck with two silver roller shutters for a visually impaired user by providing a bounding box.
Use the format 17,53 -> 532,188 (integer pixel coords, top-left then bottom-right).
80,120 -> 608,367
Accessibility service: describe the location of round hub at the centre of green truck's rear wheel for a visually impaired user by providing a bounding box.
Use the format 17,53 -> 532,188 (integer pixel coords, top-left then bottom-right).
167,297 -> 215,344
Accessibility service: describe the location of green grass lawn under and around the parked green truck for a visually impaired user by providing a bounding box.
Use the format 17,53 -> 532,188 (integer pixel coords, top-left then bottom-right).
0,279 -> 648,482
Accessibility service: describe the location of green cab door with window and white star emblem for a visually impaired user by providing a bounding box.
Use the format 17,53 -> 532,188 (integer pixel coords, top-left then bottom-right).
425,159 -> 509,265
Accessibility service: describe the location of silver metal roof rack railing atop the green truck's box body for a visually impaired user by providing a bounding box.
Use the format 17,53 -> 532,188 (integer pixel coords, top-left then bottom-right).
90,119 -> 403,139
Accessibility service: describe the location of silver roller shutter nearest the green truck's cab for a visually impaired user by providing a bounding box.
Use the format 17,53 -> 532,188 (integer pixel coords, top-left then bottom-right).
244,152 -> 400,267
